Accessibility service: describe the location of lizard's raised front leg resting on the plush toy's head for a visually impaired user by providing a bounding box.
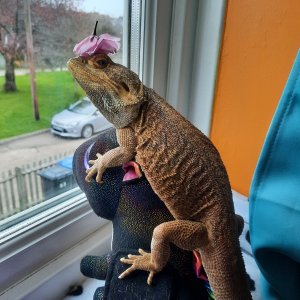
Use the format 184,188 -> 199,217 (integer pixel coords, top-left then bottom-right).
85,127 -> 136,183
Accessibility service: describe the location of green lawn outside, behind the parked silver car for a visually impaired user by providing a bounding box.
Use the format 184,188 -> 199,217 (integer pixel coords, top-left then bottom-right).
0,71 -> 84,139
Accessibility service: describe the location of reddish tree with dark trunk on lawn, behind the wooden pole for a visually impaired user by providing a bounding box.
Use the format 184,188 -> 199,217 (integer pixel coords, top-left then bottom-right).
0,0 -> 82,91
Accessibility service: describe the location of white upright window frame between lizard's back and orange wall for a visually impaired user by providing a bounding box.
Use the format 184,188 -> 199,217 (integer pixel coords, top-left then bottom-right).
142,0 -> 227,136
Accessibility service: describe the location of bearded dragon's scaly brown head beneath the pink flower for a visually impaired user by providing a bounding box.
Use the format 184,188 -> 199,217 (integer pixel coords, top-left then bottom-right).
67,54 -> 143,128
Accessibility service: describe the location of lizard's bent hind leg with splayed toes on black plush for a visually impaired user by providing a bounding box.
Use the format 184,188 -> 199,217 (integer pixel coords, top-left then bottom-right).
119,220 -> 208,284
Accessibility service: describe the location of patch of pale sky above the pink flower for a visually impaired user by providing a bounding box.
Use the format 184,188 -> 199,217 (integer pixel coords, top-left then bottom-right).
79,0 -> 124,18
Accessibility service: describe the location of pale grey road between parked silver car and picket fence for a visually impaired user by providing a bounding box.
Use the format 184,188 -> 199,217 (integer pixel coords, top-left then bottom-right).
0,130 -> 85,174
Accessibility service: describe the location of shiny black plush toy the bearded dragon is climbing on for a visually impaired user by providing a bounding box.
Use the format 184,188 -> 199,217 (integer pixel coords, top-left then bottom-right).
73,129 -> 209,300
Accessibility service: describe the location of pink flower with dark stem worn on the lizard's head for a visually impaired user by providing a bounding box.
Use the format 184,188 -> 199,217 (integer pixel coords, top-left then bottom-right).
73,33 -> 121,57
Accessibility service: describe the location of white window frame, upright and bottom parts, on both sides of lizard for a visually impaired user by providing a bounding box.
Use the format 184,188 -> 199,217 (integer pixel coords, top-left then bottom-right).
0,0 -> 226,300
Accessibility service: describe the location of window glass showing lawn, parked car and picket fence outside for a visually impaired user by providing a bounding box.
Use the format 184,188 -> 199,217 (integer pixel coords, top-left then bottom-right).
0,0 -> 124,225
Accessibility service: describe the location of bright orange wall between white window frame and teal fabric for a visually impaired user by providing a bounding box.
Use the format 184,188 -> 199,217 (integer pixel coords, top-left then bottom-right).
211,0 -> 300,195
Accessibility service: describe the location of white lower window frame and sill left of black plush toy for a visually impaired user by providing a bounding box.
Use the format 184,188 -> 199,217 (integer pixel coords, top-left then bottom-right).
0,193 -> 111,299
